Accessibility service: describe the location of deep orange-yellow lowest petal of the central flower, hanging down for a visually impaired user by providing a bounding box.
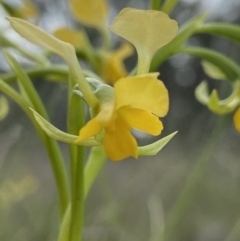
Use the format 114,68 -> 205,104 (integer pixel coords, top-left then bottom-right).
103,117 -> 138,161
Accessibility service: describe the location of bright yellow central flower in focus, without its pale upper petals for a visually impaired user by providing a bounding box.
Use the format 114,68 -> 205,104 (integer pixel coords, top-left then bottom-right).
76,73 -> 169,161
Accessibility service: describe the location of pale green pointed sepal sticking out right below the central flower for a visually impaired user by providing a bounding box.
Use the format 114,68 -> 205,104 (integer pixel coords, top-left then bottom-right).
138,131 -> 177,156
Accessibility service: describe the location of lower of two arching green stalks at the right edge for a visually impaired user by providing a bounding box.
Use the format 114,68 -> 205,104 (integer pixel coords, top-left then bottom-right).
178,47 -> 240,81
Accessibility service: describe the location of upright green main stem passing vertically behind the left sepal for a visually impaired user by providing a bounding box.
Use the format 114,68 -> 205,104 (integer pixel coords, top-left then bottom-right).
68,78 -> 85,241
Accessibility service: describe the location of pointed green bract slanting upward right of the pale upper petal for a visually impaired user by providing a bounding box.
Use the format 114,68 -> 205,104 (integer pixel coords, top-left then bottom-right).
150,14 -> 207,69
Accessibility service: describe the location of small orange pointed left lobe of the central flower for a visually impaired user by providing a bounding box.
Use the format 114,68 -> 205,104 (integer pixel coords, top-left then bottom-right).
76,118 -> 102,142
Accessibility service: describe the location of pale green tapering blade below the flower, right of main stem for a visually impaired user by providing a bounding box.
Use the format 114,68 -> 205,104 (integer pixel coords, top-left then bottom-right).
84,146 -> 107,199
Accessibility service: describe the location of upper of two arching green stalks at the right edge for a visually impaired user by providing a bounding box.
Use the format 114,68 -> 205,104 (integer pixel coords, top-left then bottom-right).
196,23 -> 240,43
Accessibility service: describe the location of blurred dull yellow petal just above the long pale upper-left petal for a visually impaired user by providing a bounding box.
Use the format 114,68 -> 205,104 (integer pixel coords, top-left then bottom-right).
53,27 -> 85,48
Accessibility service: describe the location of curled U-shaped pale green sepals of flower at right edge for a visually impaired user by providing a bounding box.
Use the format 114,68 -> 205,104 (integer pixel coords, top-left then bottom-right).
195,81 -> 240,115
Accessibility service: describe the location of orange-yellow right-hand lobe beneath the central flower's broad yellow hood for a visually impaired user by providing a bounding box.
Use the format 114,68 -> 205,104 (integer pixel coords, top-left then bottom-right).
118,107 -> 163,136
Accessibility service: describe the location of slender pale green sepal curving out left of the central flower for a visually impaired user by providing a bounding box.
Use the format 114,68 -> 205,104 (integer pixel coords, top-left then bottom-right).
30,108 -> 100,146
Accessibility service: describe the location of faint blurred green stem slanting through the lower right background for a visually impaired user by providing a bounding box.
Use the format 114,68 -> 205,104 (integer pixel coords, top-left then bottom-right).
154,117 -> 226,241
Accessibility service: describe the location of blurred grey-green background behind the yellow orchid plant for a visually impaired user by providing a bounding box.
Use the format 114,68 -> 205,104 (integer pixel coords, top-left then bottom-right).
0,0 -> 240,241
